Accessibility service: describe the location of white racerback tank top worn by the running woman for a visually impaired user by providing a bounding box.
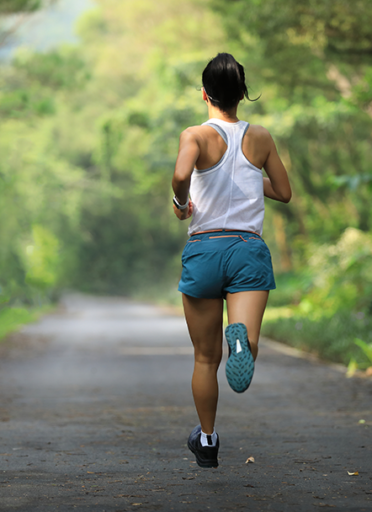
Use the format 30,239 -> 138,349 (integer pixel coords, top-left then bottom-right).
188,119 -> 265,235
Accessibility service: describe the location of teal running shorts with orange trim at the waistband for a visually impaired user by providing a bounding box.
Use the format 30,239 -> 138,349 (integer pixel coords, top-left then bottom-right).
178,230 -> 276,299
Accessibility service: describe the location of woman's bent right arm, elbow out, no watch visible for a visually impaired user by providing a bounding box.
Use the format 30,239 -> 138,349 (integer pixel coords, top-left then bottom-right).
263,132 -> 292,203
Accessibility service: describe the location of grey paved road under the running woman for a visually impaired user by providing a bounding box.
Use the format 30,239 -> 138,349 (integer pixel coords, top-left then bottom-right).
0,295 -> 372,512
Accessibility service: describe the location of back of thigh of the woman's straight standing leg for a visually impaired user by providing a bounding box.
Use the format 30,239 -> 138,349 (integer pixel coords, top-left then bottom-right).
182,293 -> 223,363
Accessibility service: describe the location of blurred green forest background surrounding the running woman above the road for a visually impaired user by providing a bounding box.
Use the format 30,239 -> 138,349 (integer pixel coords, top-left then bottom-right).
0,0 -> 372,372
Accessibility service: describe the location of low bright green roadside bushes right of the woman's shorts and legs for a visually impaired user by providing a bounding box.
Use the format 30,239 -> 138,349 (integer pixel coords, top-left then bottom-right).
263,228 -> 372,364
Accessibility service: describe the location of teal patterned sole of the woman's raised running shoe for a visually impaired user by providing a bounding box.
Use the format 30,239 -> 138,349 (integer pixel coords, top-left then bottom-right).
225,323 -> 254,393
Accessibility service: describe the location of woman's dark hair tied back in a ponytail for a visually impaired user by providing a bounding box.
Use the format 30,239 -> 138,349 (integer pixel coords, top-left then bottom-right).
202,53 -> 258,112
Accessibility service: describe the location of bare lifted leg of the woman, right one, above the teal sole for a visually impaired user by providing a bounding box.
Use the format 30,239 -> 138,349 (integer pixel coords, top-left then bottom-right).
226,290 -> 269,359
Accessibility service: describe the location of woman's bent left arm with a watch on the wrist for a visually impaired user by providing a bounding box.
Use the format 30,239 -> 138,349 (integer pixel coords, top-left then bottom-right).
172,128 -> 200,220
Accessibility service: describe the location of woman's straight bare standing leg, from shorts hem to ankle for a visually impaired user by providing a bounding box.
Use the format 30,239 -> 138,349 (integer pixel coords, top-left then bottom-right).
182,294 -> 223,434
